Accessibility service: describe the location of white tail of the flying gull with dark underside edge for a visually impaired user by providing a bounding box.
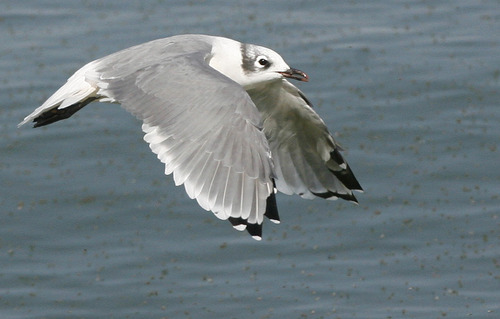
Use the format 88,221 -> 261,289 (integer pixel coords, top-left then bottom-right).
18,62 -> 100,127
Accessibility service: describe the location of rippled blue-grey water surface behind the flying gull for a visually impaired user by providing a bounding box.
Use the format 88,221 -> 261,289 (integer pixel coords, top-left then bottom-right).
0,0 -> 500,319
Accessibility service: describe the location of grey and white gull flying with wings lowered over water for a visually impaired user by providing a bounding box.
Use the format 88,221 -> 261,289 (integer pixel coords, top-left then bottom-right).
18,34 -> 363,240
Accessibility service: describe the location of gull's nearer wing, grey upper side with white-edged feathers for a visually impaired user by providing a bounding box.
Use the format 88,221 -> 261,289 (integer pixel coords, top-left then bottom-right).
95,40 -> 274,230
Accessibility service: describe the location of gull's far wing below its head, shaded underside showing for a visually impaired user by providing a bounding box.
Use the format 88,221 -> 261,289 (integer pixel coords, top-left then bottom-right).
248,80 -> 362,202
